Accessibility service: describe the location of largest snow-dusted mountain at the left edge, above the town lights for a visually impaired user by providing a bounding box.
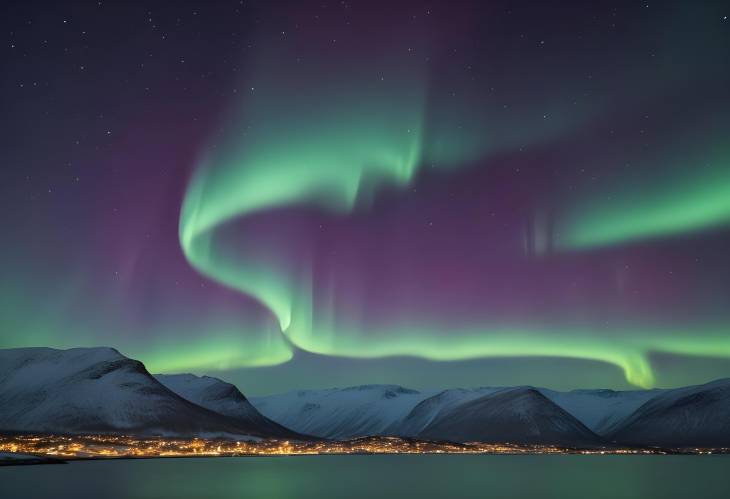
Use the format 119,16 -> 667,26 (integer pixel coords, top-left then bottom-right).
0,348 -> 298,437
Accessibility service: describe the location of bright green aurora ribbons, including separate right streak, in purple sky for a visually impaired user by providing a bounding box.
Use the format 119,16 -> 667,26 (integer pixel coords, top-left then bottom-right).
178,26 -> 730,387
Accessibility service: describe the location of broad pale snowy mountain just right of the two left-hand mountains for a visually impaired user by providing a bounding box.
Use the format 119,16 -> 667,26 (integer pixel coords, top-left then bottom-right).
251,385 -> 432,439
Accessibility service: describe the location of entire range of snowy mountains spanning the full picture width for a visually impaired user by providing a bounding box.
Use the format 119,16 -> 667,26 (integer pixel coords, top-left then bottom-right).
0,348 -> 730,447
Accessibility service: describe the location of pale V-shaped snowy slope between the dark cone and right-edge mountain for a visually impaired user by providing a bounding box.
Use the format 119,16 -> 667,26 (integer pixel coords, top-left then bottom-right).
538,388 -> 663,435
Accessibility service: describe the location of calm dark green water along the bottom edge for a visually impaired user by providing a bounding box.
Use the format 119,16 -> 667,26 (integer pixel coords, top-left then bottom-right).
0,455 -> 730,499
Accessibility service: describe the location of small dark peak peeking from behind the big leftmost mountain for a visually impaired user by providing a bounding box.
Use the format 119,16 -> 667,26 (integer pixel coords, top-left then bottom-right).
155,374 -> 301,438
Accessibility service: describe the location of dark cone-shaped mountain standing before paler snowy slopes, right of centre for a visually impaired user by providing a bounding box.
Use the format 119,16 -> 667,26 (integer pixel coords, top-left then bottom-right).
417,387 -> 602,446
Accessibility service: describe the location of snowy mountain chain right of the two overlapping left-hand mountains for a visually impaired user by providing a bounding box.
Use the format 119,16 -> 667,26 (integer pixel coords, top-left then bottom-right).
251,379 -> 730,447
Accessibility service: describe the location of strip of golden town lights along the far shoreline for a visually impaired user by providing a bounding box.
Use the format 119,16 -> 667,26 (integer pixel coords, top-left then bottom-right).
0,435 -> 716,459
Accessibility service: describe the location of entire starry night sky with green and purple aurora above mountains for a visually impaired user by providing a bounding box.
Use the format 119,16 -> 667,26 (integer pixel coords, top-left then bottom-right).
0,0 -> 730,394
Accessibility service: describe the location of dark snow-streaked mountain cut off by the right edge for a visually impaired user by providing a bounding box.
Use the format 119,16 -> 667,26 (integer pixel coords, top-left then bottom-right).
609,379 -> 730,447
